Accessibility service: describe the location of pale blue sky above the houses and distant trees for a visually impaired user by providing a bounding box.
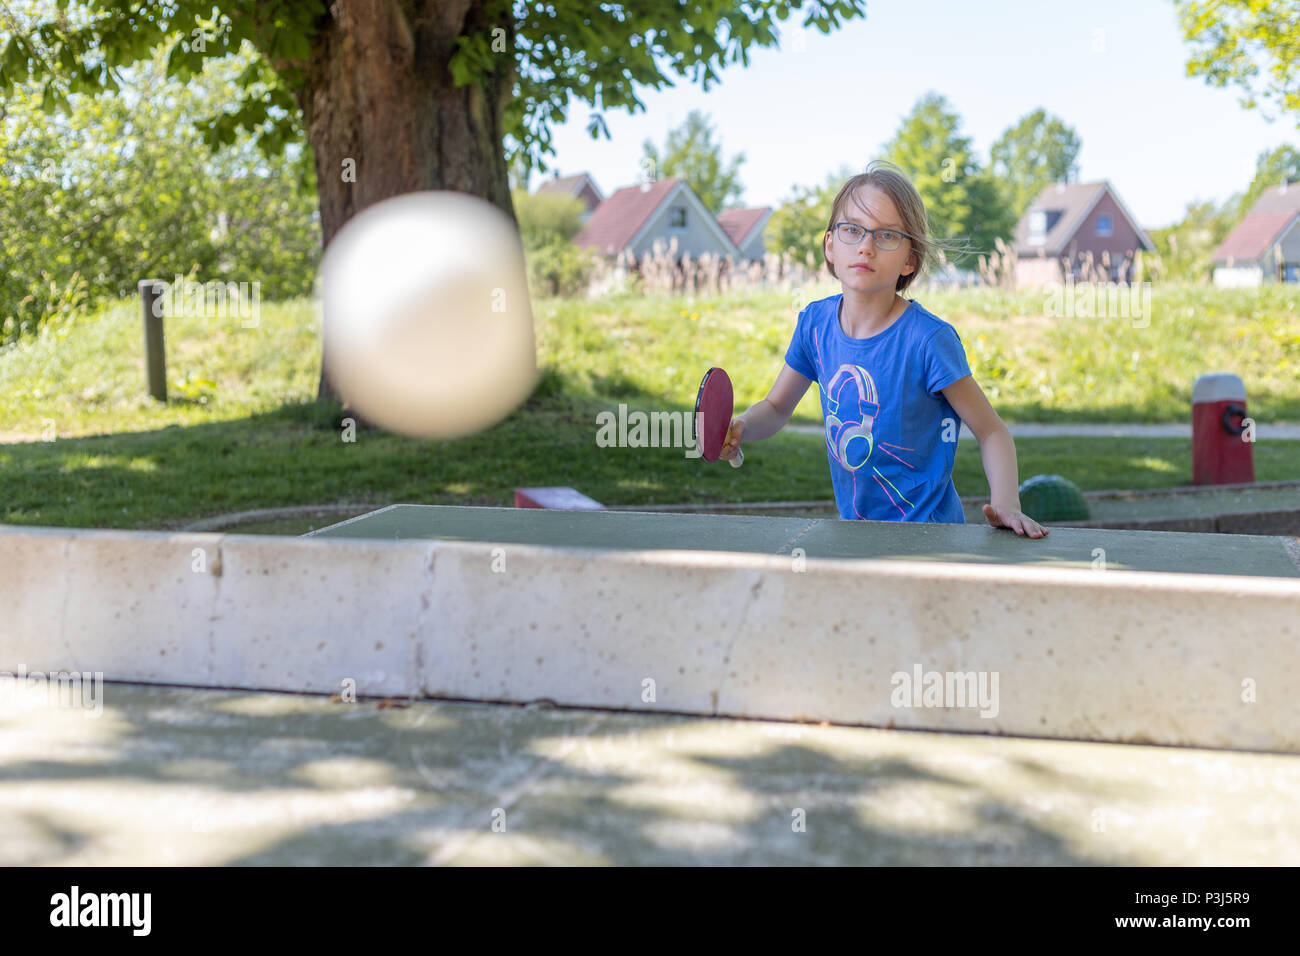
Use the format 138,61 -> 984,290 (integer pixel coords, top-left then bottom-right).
530,0 -> 1300,229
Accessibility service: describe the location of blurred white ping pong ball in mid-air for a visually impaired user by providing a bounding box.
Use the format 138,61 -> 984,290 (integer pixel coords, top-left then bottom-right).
320,191 -> 537,438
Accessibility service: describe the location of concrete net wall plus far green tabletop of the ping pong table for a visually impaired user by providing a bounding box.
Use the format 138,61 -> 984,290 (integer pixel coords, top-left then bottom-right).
0,505 -> 1300,753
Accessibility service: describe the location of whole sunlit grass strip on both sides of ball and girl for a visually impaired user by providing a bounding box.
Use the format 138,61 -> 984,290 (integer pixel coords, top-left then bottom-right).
0,274 -> 1300,438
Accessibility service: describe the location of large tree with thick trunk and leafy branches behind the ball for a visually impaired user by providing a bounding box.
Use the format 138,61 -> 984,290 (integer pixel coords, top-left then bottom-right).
0,0 -> 866,398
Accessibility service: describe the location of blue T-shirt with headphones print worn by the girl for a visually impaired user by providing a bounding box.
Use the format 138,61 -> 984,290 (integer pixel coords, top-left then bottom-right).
785,293 -> 971,524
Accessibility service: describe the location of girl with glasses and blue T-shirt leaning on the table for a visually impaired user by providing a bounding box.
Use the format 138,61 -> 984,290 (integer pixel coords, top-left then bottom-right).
722,163 -> 1048,537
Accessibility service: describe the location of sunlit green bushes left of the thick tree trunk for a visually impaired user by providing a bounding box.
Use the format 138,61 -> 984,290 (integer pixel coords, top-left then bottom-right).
0,45 -> 320,342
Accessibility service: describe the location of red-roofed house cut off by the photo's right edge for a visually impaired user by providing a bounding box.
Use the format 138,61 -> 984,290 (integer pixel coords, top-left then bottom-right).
1214,179 -> 1300,289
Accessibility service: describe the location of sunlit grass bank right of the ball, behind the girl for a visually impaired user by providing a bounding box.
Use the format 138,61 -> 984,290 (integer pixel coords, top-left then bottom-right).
537,276 -> 1300,423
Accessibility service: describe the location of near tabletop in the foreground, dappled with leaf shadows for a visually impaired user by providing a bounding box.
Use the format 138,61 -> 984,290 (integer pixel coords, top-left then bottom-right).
0,684 -> 1300,866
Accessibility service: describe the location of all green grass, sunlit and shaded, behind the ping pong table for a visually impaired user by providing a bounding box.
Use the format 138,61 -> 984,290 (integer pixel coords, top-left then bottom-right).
0,286 -> 1300,528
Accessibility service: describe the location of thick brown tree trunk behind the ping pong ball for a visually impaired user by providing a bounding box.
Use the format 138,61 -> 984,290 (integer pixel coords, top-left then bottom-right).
289,0 -> 515,401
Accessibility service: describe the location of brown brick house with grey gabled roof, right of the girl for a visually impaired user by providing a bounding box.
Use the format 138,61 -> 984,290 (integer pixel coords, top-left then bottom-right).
1013,179 -> 1156,286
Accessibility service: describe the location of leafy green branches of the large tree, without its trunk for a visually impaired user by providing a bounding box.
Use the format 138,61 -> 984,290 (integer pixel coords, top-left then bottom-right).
0,0 -> 866,210
